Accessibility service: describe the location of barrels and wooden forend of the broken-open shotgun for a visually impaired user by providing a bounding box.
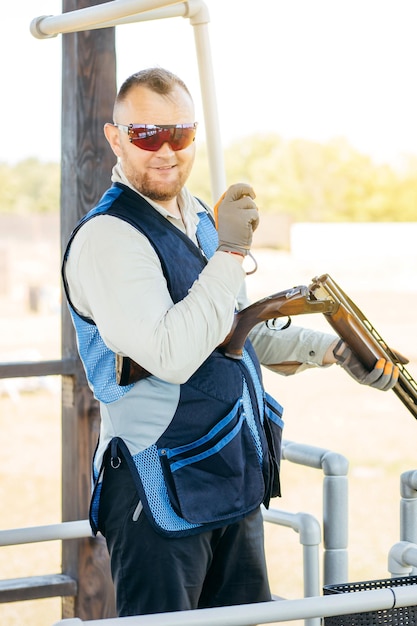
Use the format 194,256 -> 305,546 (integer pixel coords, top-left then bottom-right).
309,274 -> 417,419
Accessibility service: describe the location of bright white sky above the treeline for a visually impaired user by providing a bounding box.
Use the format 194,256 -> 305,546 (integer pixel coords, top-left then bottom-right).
0,0 -> 417,162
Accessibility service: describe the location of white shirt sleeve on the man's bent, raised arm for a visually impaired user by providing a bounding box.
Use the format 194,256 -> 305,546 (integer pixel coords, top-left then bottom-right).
66,215 -> 245,383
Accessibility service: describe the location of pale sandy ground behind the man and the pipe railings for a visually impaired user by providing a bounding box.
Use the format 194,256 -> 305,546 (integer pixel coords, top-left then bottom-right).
0,250 -> 417,626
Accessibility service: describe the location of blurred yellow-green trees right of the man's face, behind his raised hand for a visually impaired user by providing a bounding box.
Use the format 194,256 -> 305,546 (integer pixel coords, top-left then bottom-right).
191,135 -> 417,222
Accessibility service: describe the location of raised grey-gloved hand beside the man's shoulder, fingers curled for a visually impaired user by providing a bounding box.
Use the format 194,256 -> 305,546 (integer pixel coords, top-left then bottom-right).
214,183 -> 259,256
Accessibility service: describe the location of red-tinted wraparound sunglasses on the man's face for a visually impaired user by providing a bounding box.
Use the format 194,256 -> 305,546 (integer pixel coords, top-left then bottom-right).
113,122 -> 197,152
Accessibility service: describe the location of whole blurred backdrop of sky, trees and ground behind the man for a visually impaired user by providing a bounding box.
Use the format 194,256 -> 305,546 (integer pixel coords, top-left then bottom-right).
0,0 -> 417,626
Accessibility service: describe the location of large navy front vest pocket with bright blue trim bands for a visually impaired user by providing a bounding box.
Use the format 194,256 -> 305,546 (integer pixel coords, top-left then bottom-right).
158,400 -> 265,524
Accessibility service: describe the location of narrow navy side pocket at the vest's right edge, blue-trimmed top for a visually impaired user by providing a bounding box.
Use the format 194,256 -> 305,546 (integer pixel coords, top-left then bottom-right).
263,393 -> 284,508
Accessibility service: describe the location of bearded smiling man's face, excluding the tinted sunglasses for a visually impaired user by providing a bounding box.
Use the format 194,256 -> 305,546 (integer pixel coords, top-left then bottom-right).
105,86 -> 195,204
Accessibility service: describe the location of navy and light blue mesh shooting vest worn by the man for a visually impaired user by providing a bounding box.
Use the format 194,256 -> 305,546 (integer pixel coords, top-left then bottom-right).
64,183 -> 283,536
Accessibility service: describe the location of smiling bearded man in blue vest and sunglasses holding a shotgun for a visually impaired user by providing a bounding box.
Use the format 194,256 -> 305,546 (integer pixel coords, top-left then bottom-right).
63,68 -> 398,616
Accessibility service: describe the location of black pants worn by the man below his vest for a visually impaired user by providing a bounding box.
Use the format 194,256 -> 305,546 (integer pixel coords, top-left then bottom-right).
99,448 -> 271,617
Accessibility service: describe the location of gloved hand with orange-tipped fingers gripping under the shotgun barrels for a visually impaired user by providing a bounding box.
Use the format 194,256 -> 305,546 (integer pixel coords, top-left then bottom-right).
333,339 -> 399,391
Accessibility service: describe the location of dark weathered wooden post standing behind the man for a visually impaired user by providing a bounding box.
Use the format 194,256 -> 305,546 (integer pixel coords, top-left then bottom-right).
61,0 -> 116,620
